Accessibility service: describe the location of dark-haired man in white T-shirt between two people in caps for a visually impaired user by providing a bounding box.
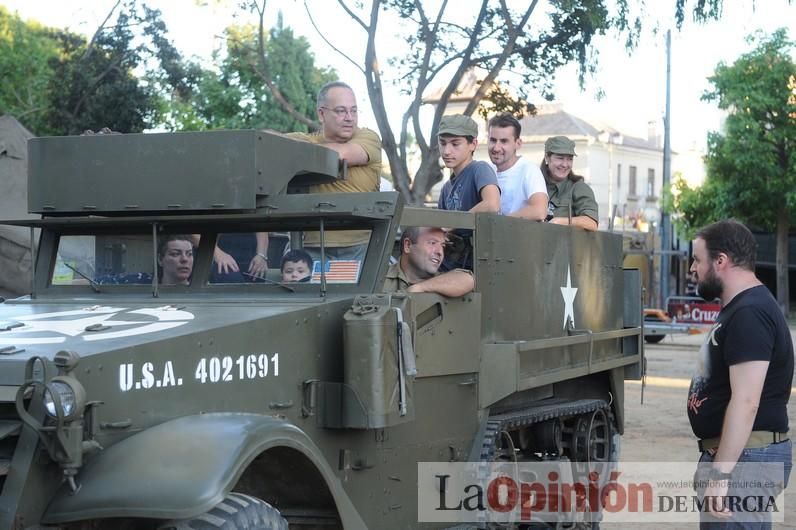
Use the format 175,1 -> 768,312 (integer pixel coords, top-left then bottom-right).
487,114 -> 547,221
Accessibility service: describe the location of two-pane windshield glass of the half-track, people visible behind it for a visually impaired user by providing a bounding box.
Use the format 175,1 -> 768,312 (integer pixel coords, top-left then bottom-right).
49,227 -> 371,291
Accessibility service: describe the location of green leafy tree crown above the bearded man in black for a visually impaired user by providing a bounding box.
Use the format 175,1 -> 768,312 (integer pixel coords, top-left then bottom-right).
705,30 -> 796,222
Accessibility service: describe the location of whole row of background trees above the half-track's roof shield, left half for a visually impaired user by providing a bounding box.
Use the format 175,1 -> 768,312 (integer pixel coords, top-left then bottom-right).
0,0 -> 336,135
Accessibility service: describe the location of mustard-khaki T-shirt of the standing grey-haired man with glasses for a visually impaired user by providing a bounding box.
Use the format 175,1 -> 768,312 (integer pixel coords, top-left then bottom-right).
287,128 -> 381,247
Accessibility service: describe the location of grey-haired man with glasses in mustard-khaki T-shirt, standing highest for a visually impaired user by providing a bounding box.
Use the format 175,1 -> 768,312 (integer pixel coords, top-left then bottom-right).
288,81 -> 381,260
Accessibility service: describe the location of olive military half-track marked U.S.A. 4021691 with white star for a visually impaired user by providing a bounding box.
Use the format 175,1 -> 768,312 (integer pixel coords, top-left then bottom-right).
0,131 -> 643,530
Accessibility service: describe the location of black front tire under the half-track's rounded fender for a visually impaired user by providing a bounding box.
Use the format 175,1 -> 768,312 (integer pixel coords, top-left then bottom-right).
158,492 -> 287,530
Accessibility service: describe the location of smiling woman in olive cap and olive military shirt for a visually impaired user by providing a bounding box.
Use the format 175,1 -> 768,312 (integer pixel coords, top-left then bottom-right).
541,136 -> 599,230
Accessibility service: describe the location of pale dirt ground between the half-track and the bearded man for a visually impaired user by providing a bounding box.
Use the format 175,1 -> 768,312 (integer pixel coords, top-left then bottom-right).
612,326 -> 796,530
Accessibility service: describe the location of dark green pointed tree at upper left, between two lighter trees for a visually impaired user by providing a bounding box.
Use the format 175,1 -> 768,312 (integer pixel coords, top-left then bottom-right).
48,0 -> 197,134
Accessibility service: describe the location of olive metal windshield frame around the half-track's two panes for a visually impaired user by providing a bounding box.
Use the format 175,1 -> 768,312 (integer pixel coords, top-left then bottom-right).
0,192 -> 403,296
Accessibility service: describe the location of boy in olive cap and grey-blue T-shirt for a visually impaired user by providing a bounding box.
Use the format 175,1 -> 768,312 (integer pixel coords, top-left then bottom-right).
437,114 -> 500,271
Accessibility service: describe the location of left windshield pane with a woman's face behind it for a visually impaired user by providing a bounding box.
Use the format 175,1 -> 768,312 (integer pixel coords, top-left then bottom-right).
50,233 -> 198,287
